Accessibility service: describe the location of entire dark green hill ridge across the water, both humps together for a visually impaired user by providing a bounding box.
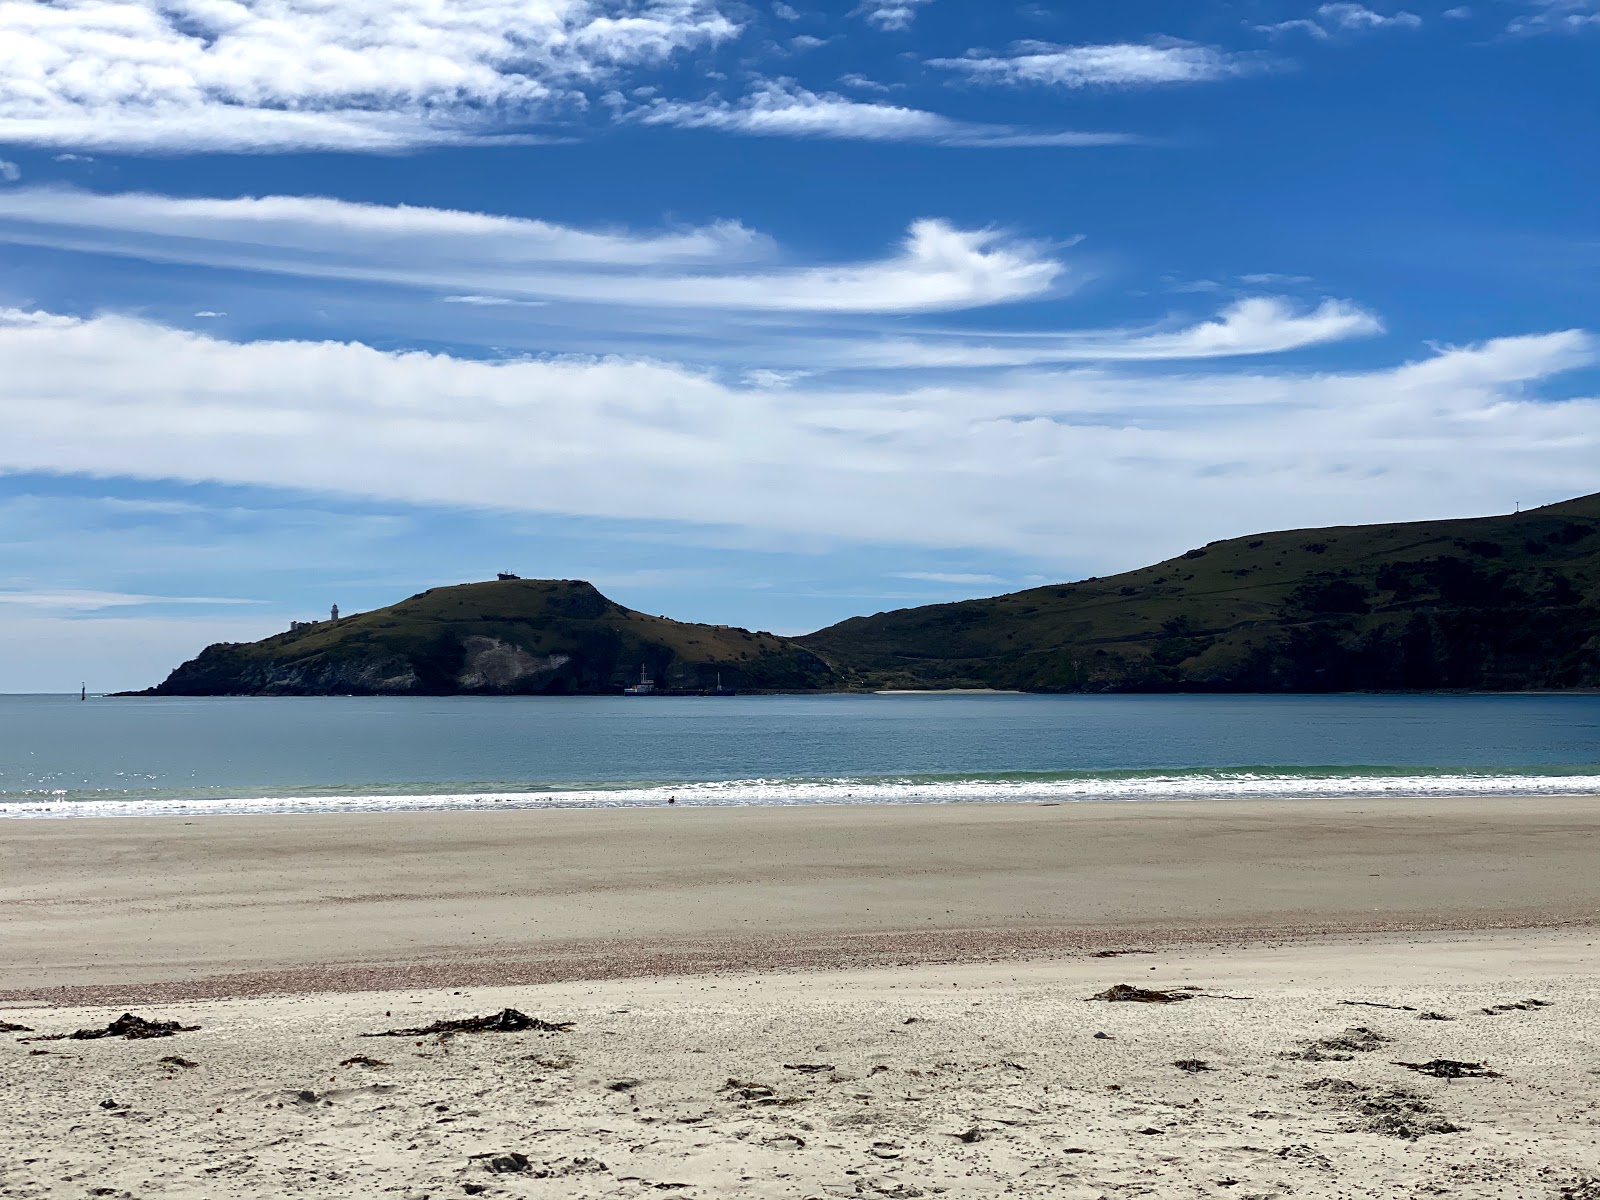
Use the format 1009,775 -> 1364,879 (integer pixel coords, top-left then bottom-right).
146,494 -> 1600,696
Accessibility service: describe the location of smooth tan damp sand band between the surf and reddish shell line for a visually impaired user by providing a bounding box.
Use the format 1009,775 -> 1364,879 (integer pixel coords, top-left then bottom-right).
0,797 -> 1600,1002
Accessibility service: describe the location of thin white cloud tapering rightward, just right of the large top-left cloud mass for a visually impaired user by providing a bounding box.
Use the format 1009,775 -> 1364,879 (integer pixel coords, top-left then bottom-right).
630,80 -> 1138,147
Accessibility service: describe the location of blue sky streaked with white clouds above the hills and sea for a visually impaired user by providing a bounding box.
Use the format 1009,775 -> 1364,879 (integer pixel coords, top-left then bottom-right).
0,0 -> 1600,691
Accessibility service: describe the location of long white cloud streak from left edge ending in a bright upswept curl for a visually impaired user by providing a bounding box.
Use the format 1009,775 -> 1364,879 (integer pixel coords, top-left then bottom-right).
0,189 -> 1064,312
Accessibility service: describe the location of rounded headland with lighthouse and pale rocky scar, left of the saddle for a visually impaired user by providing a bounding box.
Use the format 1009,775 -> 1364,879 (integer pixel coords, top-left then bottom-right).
150,579 -> 835,696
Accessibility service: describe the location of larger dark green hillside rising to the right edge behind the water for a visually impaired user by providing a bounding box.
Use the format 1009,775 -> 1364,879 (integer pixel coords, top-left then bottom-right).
795,494 -> 1600,691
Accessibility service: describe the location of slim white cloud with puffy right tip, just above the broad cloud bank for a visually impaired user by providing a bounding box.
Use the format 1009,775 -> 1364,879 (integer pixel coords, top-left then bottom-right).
840,296 -> 1384,368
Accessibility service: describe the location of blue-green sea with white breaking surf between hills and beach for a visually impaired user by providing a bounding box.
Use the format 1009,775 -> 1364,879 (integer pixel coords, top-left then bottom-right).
0,696 -> 1600,816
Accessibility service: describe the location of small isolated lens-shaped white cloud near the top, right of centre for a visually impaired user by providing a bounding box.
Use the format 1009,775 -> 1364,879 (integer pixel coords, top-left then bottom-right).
930,42 -> 1259,88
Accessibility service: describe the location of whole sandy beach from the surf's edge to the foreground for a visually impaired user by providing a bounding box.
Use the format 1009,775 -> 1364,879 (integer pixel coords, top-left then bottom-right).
0,798 -> 1600,1200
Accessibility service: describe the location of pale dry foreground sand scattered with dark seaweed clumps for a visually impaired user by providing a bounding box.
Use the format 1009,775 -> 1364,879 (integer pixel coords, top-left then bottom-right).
0,931 -> 1600,1200
